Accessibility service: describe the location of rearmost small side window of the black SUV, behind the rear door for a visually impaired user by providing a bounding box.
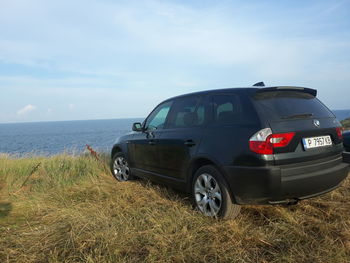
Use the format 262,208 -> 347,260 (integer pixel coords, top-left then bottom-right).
212,94 -> 242,124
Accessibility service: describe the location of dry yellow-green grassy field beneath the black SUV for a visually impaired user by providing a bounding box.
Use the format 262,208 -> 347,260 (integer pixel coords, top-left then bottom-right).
0,155 -> 350,263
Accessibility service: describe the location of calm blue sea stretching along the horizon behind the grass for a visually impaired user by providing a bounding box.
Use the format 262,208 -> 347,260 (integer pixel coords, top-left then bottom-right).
0,110 -> 350,156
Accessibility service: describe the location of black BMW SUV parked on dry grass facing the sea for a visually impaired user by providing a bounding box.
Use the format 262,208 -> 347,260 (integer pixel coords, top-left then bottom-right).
111,87 -> 349,218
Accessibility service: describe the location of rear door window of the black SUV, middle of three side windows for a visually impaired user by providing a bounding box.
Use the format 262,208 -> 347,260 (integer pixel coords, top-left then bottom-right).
167,97 -> 205,128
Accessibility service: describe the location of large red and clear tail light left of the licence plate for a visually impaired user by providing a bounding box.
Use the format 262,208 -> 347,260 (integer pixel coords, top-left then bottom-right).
249,128 -> 295,154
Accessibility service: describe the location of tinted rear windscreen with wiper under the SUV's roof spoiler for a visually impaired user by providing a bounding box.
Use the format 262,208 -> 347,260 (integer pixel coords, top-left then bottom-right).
253,91 -> 334,120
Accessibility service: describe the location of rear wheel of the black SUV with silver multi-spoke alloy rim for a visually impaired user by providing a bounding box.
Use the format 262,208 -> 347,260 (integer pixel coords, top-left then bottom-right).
192,165 -> 241,219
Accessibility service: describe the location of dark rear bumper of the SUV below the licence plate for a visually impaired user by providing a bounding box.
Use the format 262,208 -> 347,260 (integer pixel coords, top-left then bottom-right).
224,156 -> 349,204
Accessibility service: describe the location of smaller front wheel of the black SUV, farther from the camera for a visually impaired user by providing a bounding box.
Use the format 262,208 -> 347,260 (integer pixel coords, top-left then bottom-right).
110,152 -> 134,182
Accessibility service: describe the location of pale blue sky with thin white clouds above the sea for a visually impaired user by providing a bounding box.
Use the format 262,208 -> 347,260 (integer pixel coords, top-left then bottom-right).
0,0 -> 350,123
